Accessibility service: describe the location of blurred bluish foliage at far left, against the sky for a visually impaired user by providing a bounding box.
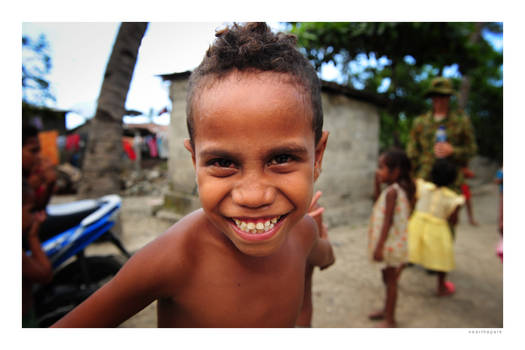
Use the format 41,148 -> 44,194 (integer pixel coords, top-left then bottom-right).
22,35 -> 55,106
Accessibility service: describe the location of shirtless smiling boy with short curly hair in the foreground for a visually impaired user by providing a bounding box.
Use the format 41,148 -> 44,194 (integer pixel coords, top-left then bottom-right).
54,23 -> 334,327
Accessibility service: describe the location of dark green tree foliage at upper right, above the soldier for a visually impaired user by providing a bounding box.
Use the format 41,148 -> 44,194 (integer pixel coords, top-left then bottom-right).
290,22 -> 503,159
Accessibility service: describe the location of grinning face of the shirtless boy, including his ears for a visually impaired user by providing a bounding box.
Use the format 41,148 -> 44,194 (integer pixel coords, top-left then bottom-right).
185,72 -> 328,256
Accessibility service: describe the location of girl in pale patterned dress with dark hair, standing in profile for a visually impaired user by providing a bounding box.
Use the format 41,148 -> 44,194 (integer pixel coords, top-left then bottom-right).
368,149 -> 415,327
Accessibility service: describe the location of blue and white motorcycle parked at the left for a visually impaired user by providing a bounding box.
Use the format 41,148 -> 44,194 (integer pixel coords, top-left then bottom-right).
30,195 -> 131,327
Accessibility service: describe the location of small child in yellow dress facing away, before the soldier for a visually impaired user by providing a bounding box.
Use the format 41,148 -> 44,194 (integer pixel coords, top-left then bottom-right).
408,159 -> 465,296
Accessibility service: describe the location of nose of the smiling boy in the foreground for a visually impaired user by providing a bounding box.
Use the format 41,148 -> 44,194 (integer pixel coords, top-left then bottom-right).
232,176 -> 275,209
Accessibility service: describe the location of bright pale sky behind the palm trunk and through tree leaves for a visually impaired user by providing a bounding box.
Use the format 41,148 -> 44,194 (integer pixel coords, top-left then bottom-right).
22,22 -> 503,128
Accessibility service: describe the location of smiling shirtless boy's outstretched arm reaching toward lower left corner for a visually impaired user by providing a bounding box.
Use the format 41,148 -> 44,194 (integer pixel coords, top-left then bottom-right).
52,232 -> 180,328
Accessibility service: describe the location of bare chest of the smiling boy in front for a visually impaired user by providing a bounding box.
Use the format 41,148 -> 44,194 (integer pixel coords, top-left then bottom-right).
157,250 -> 305,328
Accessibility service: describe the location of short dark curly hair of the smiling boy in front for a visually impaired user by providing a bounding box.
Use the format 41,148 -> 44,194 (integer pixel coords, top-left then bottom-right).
186,23 -> 323,145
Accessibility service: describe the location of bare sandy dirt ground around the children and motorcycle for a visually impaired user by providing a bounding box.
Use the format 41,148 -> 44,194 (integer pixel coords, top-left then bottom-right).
77,180 -> 503,328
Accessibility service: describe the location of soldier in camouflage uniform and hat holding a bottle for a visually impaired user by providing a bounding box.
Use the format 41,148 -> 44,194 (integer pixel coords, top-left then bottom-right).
406,78 -> 477,194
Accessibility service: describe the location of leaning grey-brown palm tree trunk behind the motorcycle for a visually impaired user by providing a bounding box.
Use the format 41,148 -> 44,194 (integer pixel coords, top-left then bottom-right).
78,22 -> 148,198
